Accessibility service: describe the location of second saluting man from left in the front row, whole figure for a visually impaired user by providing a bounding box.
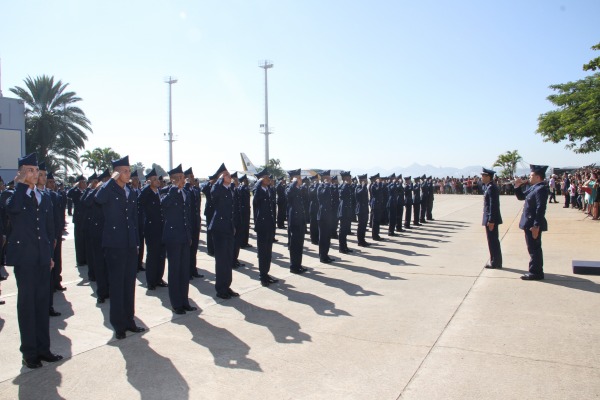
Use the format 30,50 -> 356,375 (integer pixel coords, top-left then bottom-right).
96,156 -> 145,339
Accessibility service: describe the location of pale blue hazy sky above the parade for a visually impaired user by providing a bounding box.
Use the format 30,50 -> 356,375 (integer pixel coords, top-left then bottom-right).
0,0 -> 600,176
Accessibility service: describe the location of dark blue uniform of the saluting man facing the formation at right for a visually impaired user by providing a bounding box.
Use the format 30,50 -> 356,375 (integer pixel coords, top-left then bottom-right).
515,182 -> 548,278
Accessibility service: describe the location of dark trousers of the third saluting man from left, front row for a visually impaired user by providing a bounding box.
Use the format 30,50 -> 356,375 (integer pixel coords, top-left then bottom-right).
165,243 -> 190,309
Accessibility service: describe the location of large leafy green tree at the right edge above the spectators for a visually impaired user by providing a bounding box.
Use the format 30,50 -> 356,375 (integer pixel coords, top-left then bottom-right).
536,43 -> 600,153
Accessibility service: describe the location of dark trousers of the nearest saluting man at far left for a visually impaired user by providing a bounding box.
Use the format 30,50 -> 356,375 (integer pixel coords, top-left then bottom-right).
14,264 -> 50,360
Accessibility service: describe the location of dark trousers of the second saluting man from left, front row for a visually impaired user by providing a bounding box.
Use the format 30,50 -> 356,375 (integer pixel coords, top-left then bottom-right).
104,247 -> 137,333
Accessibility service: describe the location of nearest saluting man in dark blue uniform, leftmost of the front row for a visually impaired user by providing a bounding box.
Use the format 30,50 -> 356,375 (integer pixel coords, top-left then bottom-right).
6,153 -> 62,368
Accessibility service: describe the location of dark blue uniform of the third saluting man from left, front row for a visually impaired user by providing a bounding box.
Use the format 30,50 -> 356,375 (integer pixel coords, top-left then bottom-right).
161,186 -> 193,312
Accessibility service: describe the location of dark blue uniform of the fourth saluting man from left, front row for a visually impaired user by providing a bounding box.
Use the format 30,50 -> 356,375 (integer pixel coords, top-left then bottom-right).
208,178 -> 234,297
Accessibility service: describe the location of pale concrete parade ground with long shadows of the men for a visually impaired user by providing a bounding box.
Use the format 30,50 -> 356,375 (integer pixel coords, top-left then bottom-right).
0,195 -> 600,400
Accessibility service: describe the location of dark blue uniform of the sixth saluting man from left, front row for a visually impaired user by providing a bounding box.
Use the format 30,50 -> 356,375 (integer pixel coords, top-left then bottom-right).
286,183 -> 306,271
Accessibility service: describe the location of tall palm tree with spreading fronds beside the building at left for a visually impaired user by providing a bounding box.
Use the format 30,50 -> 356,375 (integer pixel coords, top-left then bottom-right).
10,75 -> 92,170
